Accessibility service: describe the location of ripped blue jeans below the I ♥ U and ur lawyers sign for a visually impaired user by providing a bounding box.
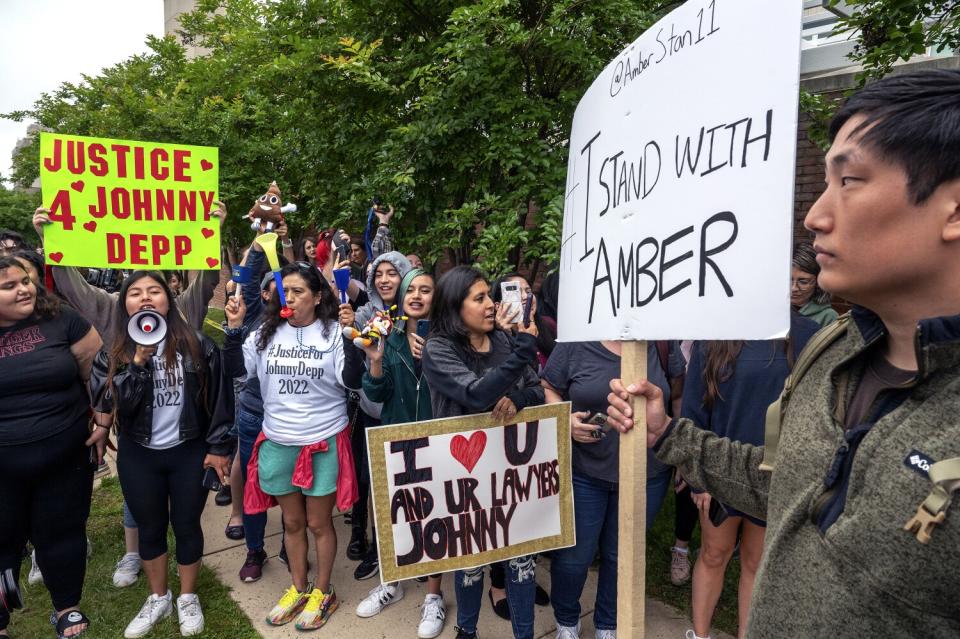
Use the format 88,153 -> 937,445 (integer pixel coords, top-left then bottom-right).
454,555 -> 537,639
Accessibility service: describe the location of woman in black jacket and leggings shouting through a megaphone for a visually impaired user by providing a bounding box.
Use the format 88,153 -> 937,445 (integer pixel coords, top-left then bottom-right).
91,271 -> 234,638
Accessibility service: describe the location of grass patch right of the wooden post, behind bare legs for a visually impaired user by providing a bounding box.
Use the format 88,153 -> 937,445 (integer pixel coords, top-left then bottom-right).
647,490 -> 740,636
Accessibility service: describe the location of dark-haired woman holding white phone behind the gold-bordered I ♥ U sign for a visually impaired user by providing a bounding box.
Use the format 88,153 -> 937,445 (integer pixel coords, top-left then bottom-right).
423,266 -> 544,639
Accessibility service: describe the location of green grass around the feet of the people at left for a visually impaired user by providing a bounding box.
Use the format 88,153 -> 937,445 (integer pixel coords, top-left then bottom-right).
8,478 -> 260,639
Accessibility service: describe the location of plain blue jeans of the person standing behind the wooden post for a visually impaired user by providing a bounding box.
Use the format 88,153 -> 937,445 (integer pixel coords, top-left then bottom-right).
550,471 -> 670,630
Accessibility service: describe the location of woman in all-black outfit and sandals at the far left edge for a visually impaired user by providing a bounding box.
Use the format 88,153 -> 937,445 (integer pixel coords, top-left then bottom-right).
0,257 -> 102,637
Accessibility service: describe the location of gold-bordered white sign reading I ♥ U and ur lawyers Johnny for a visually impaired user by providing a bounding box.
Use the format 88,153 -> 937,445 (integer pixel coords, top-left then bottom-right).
367,403 -> 576,583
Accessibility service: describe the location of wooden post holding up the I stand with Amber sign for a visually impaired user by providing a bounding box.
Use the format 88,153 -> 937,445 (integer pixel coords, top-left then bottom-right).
617,341 -> 647,637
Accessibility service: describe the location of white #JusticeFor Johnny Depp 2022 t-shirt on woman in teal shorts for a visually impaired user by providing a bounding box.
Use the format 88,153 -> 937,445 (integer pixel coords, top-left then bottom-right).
243,320 -> 347,446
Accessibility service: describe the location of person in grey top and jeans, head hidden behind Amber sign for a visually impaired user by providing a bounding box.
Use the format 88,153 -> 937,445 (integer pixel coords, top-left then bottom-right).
542,341 -> 683,639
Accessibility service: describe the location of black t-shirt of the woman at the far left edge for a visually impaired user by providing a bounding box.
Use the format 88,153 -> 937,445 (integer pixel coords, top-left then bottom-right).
0,307 -> 90,446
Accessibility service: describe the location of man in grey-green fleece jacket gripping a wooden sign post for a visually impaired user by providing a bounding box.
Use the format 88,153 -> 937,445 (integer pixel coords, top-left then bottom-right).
608,70 -> 960,638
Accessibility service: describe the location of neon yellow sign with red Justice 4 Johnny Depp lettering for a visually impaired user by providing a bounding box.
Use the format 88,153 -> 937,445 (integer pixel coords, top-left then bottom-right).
40,133 -> 220,270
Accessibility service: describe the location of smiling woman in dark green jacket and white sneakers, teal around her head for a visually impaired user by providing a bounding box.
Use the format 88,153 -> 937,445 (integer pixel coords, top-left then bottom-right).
357,268 -> 446,639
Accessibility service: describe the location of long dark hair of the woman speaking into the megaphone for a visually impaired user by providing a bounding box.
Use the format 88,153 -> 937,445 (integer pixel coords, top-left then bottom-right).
107,271 -> 206,398
